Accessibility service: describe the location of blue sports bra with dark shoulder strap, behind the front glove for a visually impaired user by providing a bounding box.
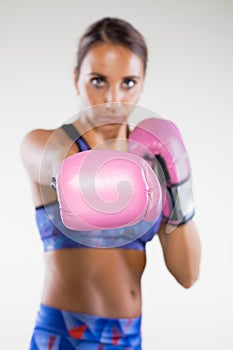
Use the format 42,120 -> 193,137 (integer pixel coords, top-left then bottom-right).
36,124 -> 162,251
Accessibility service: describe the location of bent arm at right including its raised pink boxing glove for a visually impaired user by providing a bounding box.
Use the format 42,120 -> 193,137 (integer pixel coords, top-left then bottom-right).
129,118 -> 200,288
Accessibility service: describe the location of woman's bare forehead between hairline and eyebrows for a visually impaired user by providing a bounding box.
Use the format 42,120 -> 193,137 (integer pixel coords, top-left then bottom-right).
81,44 -> 143,76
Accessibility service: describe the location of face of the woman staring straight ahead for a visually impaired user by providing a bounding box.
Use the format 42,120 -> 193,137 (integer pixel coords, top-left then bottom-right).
74,44 -> 144,124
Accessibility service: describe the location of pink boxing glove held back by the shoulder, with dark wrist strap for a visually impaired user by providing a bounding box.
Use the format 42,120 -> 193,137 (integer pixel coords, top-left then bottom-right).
129,118 -> 194,233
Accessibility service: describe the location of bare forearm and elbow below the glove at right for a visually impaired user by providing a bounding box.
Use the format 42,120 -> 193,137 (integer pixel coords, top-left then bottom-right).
159,220 -> 201,288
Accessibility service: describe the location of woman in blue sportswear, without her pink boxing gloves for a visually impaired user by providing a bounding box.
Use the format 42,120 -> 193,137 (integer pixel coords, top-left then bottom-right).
22,18 -> 200,349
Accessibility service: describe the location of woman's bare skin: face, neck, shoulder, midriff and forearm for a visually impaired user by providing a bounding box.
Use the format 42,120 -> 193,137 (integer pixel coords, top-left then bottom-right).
21,44 -> 200,318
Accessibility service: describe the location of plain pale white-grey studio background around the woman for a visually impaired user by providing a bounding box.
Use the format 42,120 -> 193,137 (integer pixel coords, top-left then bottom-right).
0,0 -> 233,350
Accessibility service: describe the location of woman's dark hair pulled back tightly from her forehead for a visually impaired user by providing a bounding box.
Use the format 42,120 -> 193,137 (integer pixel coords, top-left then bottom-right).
76,17 -> 148,72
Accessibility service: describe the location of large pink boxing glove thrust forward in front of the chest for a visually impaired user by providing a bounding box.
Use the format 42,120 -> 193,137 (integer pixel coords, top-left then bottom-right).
56,150 -> 162,231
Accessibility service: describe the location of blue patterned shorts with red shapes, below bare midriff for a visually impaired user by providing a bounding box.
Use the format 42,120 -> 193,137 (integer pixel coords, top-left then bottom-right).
29,304 -> 141,350
